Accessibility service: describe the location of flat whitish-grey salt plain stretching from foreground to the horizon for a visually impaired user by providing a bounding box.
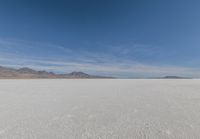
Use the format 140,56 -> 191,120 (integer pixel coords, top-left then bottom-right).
0,79 -> 200,139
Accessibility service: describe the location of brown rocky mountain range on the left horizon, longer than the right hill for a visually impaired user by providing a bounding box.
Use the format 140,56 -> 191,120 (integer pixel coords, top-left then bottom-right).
0,66 -> 112,79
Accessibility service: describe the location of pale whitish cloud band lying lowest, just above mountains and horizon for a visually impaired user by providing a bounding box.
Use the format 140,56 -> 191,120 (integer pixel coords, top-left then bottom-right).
0,54 -> 200,77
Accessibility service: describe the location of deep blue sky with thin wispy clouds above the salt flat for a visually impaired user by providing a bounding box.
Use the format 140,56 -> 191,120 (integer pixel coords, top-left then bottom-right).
0,0 -> 200,78
